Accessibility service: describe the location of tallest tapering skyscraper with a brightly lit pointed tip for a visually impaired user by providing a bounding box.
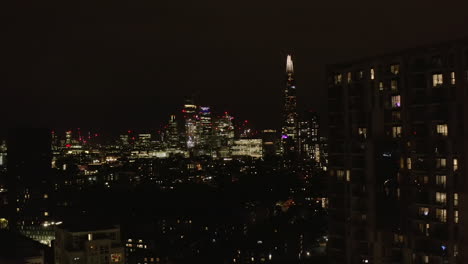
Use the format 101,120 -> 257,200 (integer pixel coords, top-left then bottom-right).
281,55 -> 298,158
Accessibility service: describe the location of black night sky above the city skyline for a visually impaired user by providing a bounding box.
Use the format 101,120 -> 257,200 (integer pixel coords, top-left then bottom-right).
0,0 -> 468,132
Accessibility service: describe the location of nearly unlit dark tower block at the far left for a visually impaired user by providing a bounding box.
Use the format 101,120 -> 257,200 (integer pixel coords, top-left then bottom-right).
7,128 -> 55,245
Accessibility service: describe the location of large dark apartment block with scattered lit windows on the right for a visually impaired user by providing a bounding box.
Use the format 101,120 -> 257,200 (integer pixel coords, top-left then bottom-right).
327,40 -> 468,264
